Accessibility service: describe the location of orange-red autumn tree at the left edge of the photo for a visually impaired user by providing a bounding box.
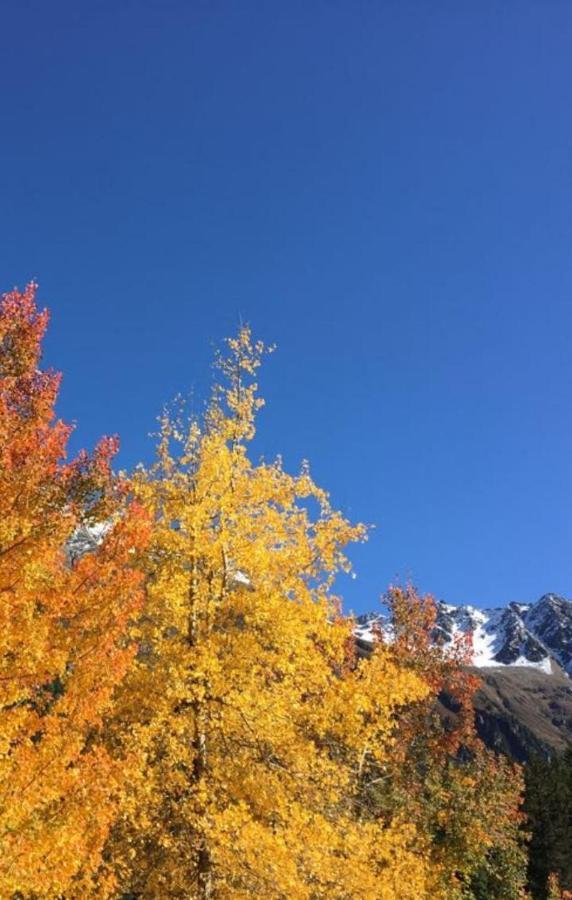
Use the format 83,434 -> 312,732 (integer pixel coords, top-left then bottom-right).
0,285 -> 150,898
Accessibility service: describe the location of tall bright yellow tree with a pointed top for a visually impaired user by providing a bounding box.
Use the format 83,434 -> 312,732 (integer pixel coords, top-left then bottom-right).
106,328 -> 428,900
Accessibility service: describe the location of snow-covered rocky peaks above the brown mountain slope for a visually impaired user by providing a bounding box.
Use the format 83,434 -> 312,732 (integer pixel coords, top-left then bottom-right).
356,594 -> 572,677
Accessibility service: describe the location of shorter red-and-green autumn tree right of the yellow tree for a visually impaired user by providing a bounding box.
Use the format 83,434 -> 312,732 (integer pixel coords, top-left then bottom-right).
368,585 -> 526,900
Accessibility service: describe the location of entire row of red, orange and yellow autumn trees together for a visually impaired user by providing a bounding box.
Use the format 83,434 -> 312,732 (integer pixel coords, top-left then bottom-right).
0,286 -> 536,900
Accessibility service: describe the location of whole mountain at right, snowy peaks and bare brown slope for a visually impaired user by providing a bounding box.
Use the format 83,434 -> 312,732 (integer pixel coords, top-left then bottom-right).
356,594 -> 572,762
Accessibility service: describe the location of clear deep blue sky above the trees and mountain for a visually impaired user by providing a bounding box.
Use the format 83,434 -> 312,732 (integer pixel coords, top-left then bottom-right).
0,0 -> 572,611
